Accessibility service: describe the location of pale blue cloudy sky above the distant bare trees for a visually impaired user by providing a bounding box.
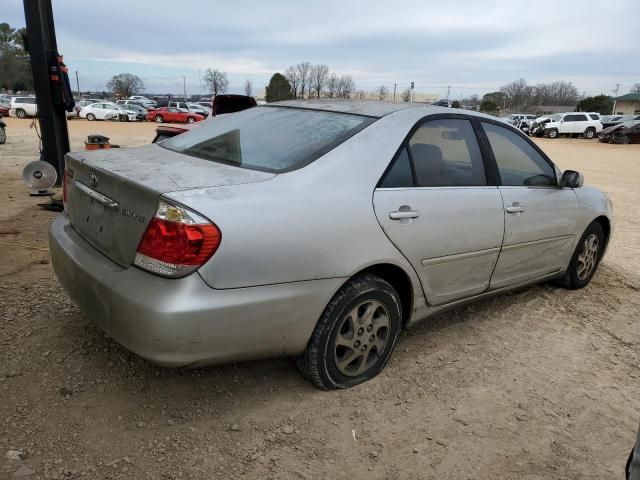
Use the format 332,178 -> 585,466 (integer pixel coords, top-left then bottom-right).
0,0 -> 640,99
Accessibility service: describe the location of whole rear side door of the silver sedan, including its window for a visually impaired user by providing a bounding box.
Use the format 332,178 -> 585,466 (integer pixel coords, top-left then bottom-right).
373,115 -> 504,305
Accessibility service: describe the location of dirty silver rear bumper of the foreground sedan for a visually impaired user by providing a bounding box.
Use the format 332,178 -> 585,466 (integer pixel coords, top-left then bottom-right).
49,214 -> 343,367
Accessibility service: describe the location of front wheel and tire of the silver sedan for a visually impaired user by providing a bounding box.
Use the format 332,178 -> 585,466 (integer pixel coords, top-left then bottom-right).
560,222 -> 605,290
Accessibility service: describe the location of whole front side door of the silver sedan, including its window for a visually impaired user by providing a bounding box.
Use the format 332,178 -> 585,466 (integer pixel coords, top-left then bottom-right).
481,121 -> 578,288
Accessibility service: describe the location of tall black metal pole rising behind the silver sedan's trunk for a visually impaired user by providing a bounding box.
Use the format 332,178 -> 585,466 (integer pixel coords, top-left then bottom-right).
24,0 -> 70,185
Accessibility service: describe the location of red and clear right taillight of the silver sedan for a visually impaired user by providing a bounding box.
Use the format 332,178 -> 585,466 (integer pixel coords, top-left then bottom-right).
134,200 -> 222,277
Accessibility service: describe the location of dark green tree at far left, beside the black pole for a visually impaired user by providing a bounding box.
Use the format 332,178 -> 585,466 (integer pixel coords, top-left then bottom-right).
0,23 -> 33,92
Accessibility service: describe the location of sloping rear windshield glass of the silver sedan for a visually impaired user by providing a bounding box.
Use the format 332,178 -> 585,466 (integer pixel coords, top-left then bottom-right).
162,106 -> 375,173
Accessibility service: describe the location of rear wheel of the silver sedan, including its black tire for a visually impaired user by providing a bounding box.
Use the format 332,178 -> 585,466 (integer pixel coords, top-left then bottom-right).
296,274 -> 402,390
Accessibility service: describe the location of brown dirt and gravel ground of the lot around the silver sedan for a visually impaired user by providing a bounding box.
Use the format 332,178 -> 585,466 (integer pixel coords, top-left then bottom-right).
0,119 -> 640,480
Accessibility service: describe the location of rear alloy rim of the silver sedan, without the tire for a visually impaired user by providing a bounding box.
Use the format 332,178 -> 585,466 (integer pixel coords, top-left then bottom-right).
334,300 -> 390,377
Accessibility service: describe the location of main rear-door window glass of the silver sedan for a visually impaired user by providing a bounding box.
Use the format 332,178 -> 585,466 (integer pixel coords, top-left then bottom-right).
409,119 -> 487,187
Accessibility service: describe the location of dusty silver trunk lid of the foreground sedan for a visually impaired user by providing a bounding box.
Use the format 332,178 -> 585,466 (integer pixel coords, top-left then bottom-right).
65,145 -> 275,267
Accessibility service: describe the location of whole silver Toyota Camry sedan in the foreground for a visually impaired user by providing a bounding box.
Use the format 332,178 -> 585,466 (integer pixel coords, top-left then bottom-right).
49,100 -> 613,389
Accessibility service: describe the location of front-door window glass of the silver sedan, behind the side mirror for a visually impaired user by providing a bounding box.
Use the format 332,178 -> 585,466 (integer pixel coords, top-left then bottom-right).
482,122 -> 557,187
